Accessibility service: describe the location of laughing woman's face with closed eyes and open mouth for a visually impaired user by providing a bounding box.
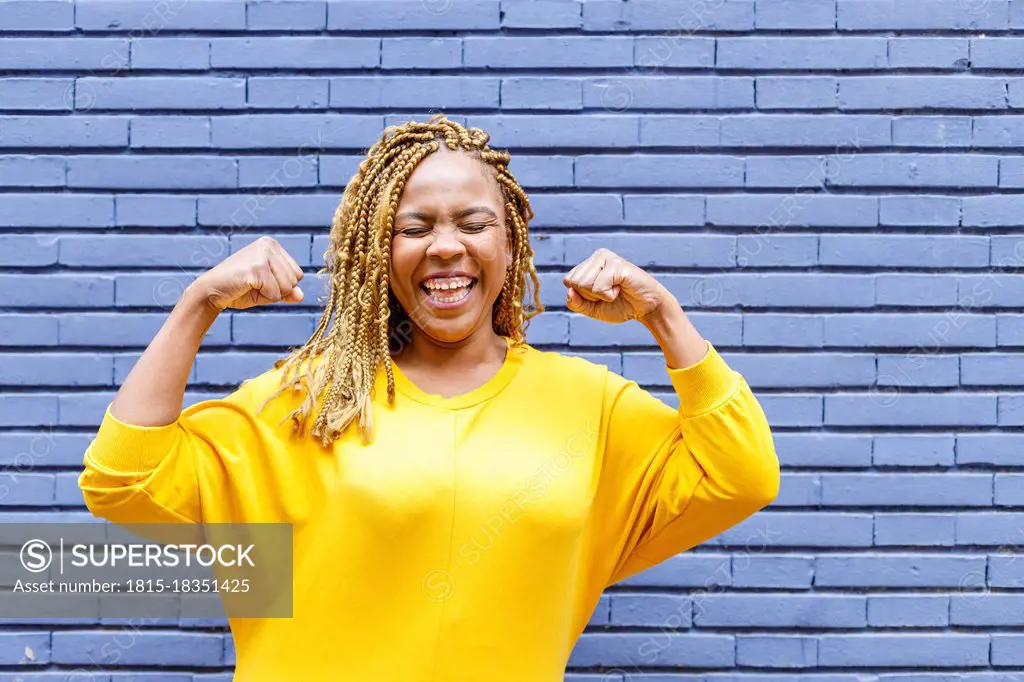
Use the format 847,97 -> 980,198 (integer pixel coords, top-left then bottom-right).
390,144 -> 512,343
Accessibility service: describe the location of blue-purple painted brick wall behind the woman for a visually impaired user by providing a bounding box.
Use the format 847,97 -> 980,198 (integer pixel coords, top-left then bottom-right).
0,0 -> 1024,682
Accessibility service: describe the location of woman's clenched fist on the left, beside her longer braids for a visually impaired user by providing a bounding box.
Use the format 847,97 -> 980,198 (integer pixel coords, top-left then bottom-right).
189,237 -> 303,310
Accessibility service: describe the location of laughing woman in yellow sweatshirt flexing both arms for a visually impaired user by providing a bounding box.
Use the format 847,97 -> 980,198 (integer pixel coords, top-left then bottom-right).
79,115 -> 779,682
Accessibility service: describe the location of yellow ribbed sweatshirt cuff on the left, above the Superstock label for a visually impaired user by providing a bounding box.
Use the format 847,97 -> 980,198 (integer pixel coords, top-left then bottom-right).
87,401 -> 178,474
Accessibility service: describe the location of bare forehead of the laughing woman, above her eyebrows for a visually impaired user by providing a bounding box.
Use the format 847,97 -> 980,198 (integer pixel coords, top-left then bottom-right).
401,145 -> 501,205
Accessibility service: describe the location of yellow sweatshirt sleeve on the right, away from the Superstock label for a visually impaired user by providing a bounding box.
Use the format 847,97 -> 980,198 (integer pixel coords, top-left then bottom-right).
595,342 -> 779,585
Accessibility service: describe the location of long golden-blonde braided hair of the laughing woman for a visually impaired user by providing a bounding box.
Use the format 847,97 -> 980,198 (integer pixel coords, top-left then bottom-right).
260,114 -> 544,446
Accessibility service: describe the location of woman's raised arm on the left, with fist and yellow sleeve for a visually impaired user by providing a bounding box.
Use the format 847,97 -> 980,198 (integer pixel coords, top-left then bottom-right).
78,238 -> 302,523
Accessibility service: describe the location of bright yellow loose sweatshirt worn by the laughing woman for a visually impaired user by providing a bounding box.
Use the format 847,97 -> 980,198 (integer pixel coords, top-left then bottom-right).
79,335 -> 779,682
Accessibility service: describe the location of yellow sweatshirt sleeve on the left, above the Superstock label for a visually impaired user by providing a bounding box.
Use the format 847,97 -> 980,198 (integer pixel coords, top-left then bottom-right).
78,364 -> 296,523
